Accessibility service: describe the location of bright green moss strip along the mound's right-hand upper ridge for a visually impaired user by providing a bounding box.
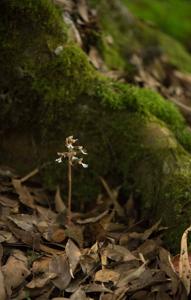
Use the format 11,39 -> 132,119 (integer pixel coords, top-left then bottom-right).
93,79 -> 191,151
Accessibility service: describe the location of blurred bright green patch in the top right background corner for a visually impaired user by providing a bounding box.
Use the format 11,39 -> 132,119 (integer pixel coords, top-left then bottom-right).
122,0 -> 191,51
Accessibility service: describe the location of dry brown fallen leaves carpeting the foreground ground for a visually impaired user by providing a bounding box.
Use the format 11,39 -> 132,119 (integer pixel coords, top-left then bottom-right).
0,165 -> 191,300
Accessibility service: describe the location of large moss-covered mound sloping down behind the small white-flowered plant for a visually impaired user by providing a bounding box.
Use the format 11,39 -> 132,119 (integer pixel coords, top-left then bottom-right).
0,0 -> 191,248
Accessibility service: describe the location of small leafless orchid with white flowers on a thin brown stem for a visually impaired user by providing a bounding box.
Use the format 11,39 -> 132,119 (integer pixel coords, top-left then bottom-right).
56,135 -> 88,224
